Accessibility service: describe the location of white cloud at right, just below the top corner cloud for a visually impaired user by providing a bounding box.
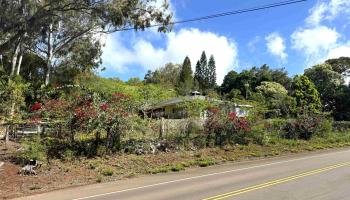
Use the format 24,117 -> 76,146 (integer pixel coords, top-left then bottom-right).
291,26 -> 340,65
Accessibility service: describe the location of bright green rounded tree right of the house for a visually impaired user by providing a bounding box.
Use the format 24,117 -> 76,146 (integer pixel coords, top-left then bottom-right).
292,75 -> 321,112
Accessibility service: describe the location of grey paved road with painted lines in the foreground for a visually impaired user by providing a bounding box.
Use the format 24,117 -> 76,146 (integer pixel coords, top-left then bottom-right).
16,149 -> 350,200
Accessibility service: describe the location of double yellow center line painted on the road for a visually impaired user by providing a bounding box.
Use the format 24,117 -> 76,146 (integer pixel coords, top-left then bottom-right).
203,161 -> 350,200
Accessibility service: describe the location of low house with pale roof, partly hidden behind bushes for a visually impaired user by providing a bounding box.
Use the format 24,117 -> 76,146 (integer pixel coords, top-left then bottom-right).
145,91 -> 253,119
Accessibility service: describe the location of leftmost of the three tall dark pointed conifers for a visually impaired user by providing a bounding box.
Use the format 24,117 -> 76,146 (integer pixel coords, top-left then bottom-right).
177,56 -> 193,95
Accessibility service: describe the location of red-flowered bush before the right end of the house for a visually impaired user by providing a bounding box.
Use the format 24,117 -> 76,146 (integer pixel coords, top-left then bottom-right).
205,109 -> 253,145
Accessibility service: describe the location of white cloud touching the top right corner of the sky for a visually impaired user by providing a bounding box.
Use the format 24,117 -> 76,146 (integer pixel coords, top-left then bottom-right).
306,0 -> 350,26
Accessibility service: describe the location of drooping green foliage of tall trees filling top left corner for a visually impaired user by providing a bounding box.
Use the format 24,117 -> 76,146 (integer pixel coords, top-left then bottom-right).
0,0 -> 172,85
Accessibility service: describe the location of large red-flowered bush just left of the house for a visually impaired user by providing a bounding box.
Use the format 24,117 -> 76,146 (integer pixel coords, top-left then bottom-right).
74,93 -> 131,151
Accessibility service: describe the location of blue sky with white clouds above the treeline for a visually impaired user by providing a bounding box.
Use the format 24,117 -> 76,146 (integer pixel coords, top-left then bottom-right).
99,0 -> 350,84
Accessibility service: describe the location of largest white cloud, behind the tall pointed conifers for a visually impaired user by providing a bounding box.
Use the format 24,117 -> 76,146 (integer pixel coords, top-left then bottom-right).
102,28 -> 238,84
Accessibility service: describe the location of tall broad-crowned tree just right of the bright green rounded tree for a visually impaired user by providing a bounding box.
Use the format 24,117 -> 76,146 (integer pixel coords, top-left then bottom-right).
304,64 -> 343,111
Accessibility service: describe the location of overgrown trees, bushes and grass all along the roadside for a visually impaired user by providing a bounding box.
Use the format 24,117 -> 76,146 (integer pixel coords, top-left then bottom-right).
0,0 -> 350,194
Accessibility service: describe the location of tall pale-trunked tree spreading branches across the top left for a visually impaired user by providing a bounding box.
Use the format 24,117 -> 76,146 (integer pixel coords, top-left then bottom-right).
0,0 -> 172,84
